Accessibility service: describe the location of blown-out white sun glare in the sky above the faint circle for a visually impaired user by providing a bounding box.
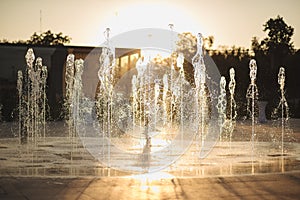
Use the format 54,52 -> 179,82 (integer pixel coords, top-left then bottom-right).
98,2 -> 203,43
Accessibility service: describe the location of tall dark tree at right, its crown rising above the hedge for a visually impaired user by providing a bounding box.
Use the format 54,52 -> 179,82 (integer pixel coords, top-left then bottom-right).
251,16 -> 294,103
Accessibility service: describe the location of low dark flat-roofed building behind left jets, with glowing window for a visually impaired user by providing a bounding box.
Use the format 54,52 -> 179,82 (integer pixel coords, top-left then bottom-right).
0,44 -> 141,121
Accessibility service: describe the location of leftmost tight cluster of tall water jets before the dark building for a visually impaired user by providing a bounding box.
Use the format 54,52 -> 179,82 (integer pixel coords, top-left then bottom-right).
17,49 -> 48,146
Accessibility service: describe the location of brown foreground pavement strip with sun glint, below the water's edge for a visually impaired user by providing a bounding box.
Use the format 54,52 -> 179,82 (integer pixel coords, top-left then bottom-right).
0,172 -> 300,200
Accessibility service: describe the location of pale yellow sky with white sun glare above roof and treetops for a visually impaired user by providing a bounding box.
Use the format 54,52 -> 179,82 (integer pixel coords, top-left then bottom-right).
0,0 -> 300,48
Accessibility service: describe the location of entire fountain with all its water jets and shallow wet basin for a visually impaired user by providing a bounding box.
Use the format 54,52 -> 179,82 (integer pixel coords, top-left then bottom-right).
0,26 -> 299,180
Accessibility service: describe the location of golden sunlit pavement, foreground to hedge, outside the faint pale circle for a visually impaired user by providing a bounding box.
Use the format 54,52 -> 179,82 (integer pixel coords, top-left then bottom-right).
0,120 -> 300,199
